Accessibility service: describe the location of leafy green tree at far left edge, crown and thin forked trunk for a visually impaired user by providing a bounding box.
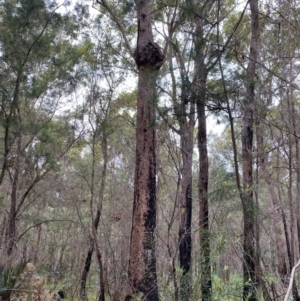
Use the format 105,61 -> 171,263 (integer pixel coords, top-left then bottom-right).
0,0 -> 86,256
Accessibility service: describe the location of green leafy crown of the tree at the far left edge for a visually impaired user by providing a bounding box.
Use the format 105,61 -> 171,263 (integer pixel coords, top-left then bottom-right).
0,0 -> 86,176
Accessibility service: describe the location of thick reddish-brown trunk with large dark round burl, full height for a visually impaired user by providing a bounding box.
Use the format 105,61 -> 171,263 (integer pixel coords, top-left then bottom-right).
128,0 -> 163,301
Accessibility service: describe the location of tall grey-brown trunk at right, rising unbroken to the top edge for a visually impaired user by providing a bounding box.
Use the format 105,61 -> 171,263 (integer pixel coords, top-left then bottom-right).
241,0 -> 259,301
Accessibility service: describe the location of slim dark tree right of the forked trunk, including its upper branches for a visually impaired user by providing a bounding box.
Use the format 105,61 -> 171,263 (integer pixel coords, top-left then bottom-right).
186,1 -> 232,300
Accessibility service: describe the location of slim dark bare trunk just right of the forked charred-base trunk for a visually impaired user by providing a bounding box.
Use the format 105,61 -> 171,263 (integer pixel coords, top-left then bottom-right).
193,8 -> 212,301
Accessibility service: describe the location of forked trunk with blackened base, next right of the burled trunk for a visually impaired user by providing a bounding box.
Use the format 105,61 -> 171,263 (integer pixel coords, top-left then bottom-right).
168,27 -> 195,301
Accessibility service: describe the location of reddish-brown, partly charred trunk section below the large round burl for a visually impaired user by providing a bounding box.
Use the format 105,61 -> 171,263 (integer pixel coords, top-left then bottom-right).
129,66 -> 159,301
